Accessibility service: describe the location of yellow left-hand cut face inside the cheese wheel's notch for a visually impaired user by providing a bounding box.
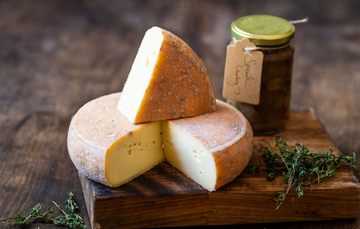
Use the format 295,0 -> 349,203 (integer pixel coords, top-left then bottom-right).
105,121 -> 164,187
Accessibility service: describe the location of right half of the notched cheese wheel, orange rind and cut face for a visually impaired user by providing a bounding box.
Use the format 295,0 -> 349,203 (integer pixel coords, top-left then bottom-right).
162,100 -> 253,191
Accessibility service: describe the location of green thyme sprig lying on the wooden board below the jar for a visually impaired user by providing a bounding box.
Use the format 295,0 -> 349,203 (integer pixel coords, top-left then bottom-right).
258,136 -> 357,212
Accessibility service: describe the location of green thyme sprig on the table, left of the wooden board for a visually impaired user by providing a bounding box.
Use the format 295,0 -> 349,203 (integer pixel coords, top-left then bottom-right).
0,192 -> 86,229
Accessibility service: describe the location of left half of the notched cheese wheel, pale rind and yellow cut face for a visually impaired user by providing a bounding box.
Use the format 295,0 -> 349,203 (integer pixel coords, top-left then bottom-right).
68,93 -> 164,187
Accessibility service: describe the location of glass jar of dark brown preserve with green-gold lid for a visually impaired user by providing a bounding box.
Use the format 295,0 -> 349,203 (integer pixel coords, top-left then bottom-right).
226,15 -> 295,135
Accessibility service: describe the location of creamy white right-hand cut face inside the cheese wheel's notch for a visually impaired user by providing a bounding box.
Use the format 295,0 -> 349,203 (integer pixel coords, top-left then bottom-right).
162,121 -> 216,191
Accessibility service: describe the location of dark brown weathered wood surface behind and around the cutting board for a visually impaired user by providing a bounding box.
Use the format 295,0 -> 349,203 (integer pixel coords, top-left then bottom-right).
0,0 -> 360,229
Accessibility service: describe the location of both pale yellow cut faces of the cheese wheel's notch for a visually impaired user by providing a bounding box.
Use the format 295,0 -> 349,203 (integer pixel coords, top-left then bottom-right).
105,121 -> 216,191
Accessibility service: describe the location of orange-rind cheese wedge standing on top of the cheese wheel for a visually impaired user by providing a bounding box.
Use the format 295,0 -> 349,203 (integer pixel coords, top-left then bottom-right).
117,27 -> 216,123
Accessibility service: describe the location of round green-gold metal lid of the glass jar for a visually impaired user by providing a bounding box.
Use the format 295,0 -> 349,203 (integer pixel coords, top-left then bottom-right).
231,14 -> 295,46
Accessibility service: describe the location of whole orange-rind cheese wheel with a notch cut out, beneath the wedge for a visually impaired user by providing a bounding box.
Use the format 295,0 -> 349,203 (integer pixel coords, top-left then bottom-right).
68,93 -> 253,191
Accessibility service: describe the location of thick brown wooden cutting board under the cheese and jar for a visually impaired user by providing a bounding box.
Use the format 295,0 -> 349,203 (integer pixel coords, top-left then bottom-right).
79,109 -> 360,228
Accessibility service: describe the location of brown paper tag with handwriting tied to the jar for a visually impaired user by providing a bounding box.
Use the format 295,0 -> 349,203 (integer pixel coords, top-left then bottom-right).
223,38 -> 264,105
